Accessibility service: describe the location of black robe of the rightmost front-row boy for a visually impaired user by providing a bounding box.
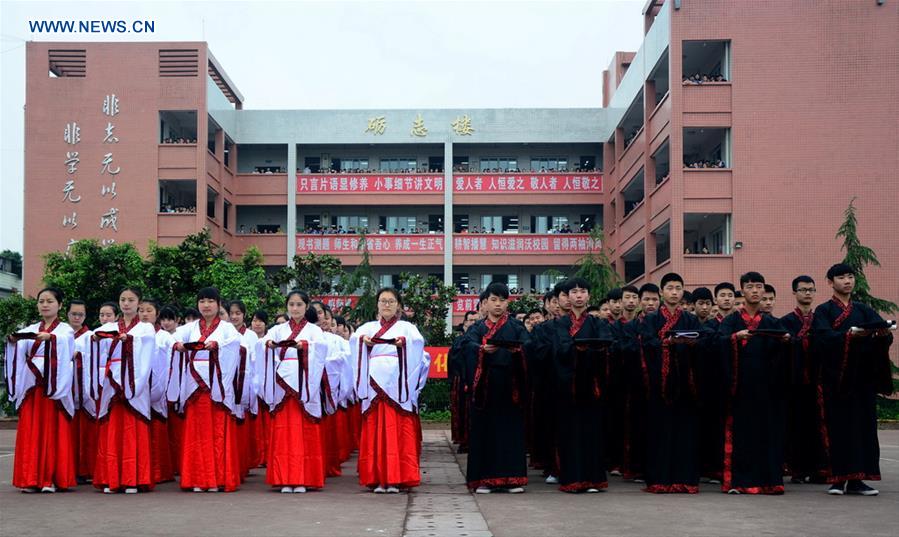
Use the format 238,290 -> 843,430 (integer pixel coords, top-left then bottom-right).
812,298 -> 893,483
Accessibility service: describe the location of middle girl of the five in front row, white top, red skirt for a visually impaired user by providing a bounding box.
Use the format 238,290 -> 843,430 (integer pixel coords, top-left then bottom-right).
169,287 -> 242,492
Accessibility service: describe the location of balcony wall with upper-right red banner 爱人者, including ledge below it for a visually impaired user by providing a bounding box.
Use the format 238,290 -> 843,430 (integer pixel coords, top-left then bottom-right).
453,171 -> 603,205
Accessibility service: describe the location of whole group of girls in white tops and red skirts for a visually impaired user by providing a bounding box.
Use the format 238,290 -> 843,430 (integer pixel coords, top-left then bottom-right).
5,287 -> 430,494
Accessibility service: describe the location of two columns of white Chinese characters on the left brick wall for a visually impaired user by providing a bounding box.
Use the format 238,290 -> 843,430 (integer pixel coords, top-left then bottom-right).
62,93 -> 122,251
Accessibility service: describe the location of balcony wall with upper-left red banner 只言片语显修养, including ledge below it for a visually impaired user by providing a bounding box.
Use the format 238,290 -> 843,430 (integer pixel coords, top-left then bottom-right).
297,173 -> 445,205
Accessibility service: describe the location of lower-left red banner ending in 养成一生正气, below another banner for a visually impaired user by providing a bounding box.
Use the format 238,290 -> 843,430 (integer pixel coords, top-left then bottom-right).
297,234 -> 443,254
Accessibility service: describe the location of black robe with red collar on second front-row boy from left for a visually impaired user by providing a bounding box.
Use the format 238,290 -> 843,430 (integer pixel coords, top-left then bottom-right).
541,313 -> 612,492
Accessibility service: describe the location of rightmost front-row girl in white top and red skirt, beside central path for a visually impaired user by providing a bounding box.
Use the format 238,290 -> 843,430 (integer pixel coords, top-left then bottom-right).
350,288 -> 425,493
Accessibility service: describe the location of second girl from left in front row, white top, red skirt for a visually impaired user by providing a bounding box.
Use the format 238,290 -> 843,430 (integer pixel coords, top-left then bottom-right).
90,287 -> 156,494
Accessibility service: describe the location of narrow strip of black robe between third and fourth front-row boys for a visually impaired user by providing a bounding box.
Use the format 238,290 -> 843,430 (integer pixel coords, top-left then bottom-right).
698,316 -> 730,482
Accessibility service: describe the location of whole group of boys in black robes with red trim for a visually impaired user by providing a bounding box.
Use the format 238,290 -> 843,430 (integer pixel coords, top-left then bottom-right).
449,264 -> 895,496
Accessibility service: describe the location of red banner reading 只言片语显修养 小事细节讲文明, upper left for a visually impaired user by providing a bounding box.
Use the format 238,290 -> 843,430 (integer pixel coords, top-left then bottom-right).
297,173 -> 444,194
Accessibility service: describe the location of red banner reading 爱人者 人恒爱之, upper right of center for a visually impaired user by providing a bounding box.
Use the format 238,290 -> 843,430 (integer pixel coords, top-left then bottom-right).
453,173 -> 602,193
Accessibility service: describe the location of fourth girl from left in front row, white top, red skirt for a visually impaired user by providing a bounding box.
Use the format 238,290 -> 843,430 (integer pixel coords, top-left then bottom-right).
256,290 -> 328,493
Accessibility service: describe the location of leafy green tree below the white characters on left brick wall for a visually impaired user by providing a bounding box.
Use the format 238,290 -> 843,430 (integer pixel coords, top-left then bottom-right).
44,240 -> 144,314
